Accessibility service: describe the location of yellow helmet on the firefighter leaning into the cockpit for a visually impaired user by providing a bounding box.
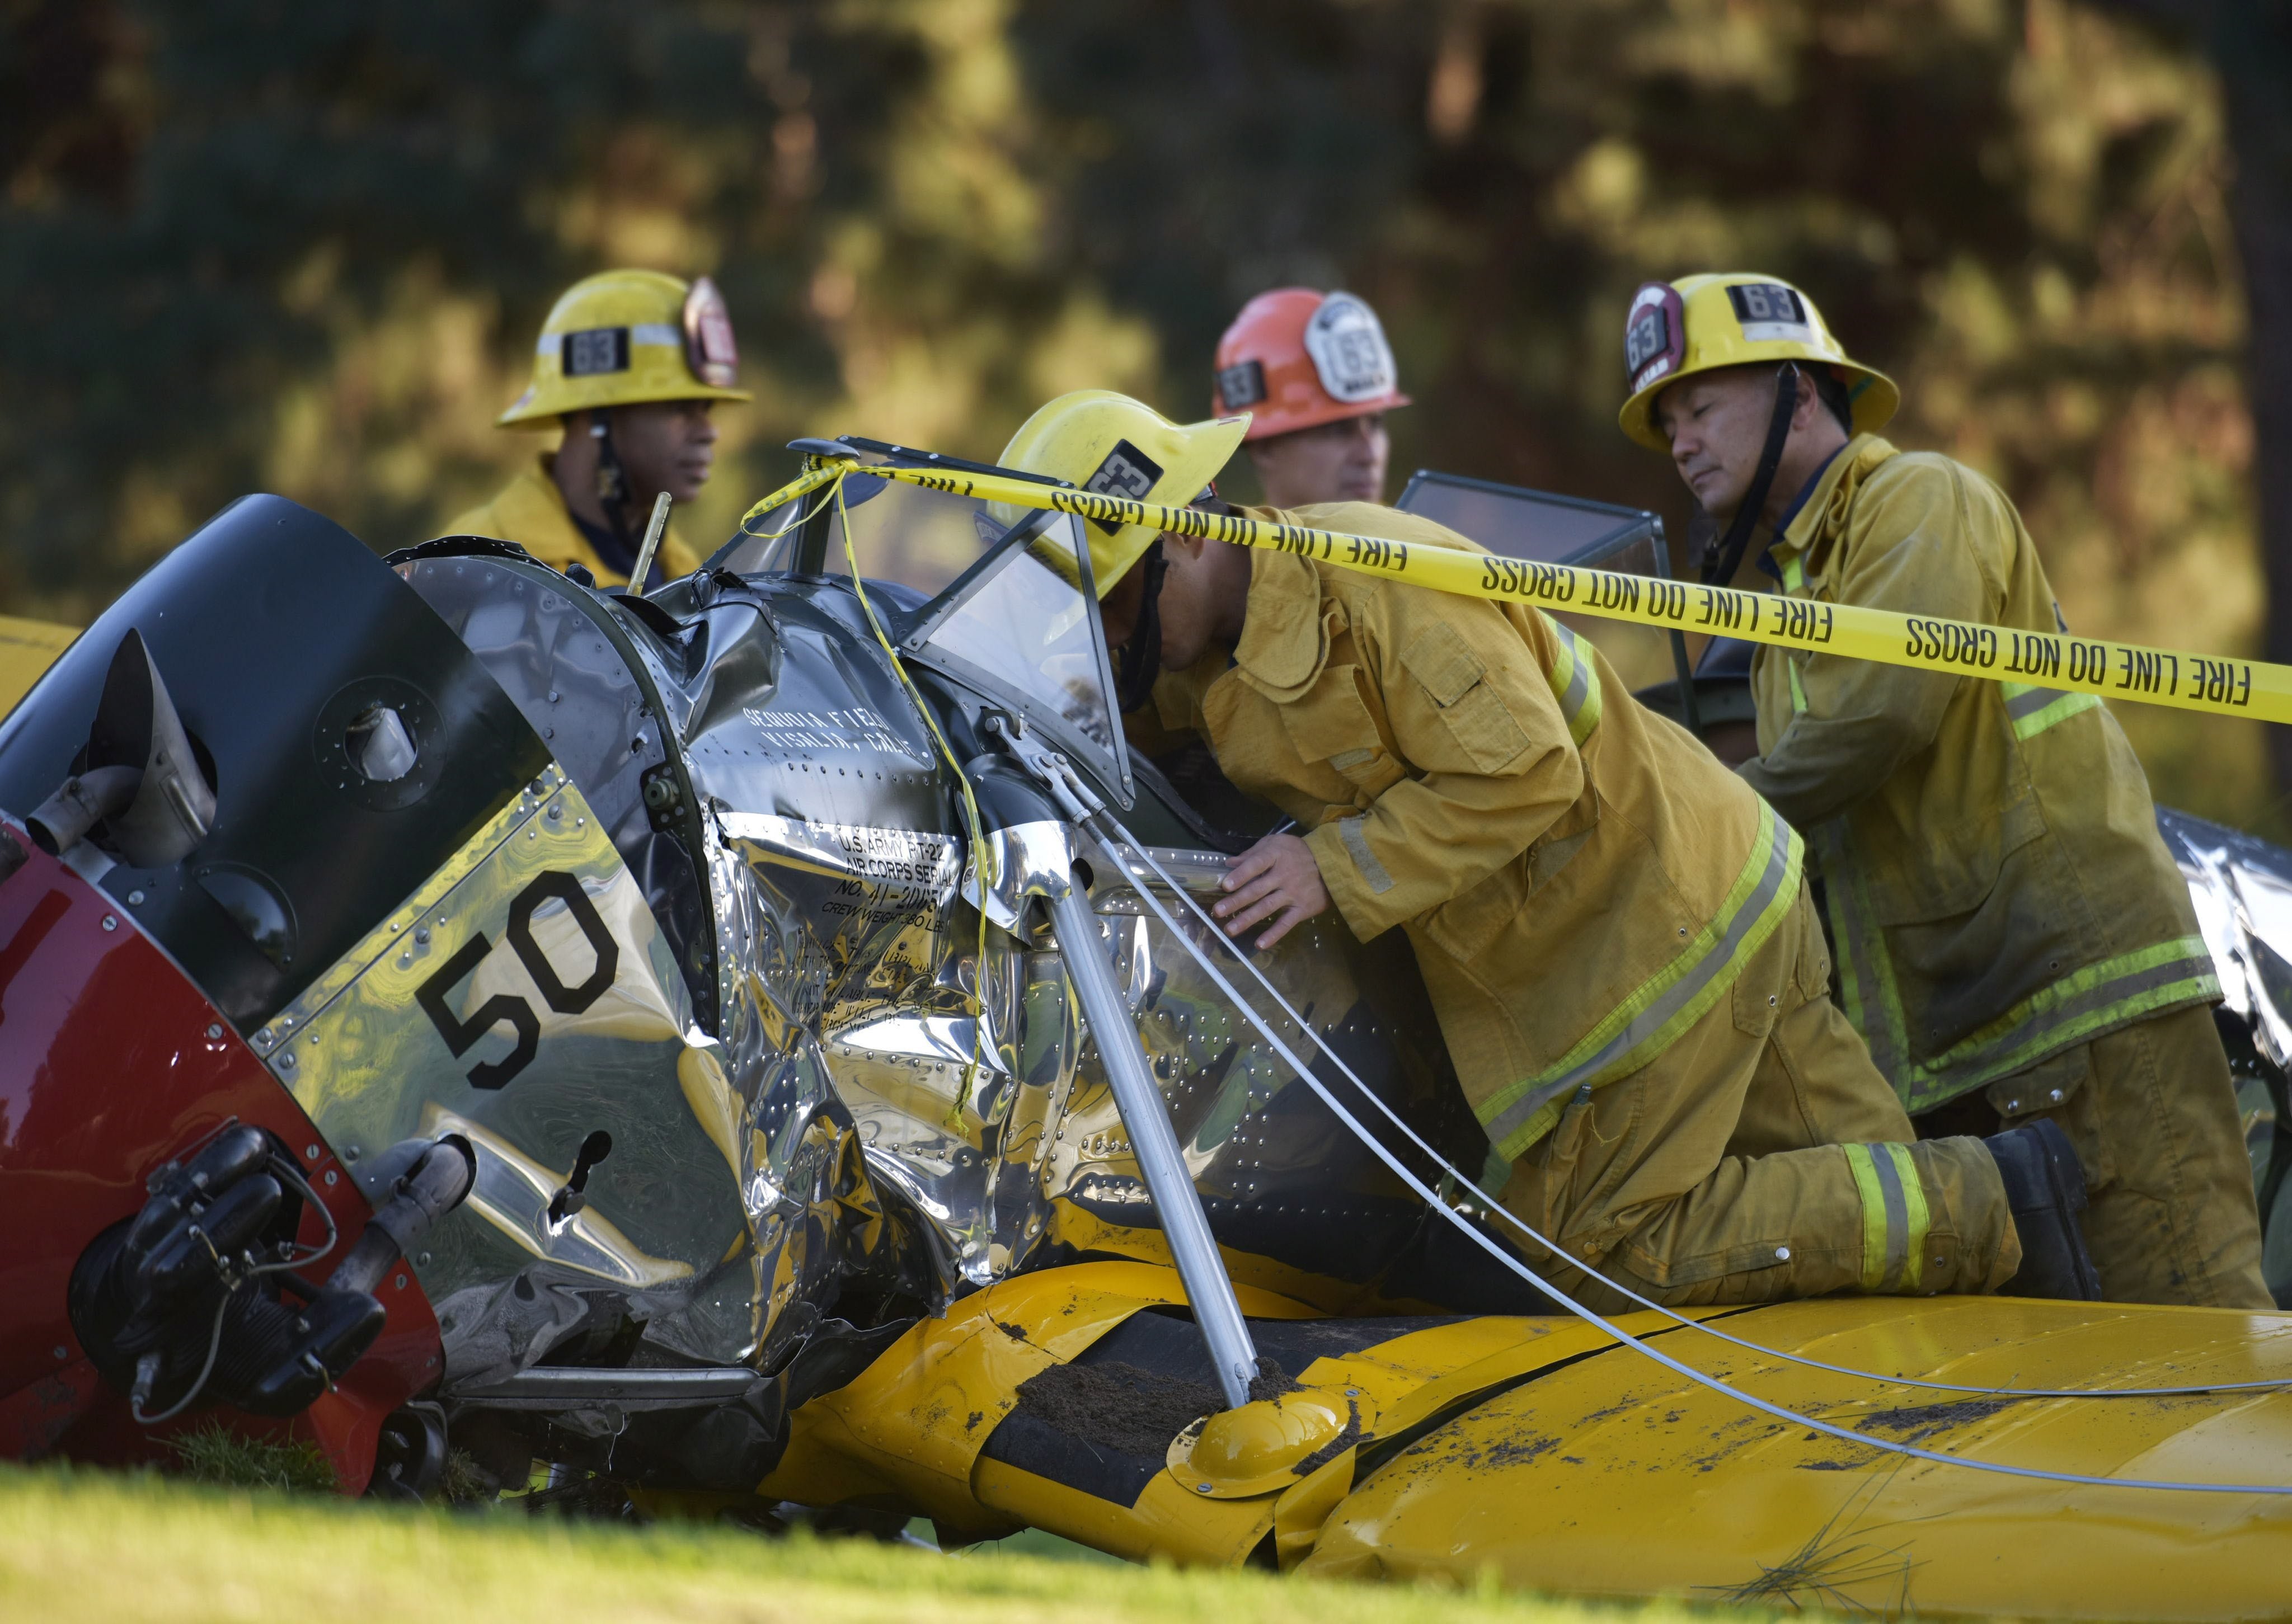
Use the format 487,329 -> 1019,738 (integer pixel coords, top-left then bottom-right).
997,389 -> 1249,598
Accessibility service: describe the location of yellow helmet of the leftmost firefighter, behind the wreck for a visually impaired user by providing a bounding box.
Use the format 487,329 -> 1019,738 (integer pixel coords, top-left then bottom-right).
495,270 -> 754,429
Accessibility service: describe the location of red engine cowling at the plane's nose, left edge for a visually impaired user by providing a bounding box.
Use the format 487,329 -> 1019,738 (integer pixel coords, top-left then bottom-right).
0,827 -> 443,1494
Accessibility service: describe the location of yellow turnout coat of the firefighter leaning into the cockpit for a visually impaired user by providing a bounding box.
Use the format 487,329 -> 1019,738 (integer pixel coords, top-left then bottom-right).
1155,504 -> 1801,1157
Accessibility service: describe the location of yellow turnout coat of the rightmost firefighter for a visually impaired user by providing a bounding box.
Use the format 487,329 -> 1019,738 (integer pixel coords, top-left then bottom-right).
1742,435 -> 2221,1111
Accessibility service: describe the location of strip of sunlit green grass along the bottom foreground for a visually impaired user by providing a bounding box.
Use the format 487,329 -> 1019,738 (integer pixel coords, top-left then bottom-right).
0,1466 -> 1741,1624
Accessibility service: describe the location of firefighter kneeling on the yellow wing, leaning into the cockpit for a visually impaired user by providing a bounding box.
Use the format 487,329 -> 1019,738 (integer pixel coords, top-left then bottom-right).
1002,389 -> 2093,1308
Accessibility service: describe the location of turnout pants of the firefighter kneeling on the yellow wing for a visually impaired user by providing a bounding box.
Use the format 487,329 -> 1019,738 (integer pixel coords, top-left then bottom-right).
1504,887 -> 2017,1312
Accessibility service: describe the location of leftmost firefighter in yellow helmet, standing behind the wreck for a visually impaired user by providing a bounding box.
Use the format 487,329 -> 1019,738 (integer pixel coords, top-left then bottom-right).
445,270 -> 752,586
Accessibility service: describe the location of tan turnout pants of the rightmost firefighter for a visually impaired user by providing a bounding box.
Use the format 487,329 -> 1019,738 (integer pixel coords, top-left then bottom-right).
1918,1003 -> 2276,1308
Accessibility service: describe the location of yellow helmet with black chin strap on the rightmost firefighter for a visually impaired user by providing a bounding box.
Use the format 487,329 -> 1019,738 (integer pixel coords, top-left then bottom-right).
1616,270 -> 1903,451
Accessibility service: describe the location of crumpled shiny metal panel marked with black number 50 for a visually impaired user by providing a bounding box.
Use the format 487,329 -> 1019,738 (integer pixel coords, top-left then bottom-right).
257,751 -> 908,1392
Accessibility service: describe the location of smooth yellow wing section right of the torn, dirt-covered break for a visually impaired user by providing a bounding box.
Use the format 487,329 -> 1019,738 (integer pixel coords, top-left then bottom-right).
1304,1296 -> 2292,1620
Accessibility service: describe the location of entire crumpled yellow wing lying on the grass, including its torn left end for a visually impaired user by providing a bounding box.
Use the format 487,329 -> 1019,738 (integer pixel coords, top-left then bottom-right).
761,1262 -> 2292,1620
